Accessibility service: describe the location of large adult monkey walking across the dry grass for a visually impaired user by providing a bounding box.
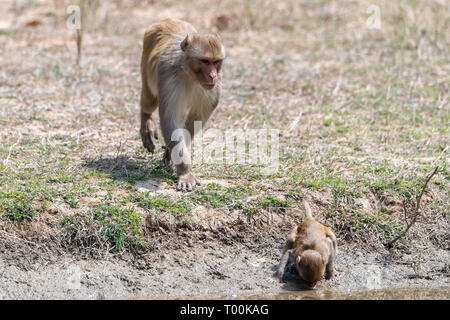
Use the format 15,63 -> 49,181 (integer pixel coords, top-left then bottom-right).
140,19 -> 225,191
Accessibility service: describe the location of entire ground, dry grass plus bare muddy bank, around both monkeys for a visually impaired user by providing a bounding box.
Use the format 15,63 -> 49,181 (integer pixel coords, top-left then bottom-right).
0,0 -> 450,299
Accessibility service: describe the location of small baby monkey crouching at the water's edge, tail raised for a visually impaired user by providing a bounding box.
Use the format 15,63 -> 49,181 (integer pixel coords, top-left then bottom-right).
277,200 -> 337,288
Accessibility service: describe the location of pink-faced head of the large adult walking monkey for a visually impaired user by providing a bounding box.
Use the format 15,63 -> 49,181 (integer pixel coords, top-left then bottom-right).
180,34 -> 225,90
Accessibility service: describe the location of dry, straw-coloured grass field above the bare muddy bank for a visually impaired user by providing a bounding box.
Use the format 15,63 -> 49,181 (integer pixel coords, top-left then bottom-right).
0,0 -> 450,255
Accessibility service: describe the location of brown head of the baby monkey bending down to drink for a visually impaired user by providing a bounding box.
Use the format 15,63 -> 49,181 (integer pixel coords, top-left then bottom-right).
295,250 -> 326,288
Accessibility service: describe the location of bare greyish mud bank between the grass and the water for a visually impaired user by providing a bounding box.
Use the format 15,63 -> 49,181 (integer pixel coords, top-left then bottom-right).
0,235 -> 449,299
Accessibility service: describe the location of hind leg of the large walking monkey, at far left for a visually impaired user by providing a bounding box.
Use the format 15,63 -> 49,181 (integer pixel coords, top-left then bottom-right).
140,84 -> 158,153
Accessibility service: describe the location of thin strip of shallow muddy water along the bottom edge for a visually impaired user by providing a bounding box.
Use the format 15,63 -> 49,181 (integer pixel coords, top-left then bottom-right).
144,287 -> 450,300
